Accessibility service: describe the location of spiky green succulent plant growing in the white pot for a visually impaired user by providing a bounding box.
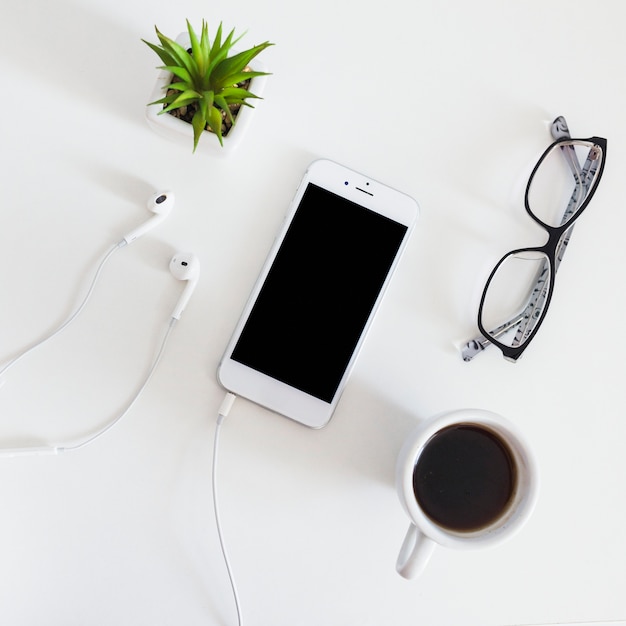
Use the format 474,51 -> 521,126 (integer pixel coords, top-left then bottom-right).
142,20 -> 273,152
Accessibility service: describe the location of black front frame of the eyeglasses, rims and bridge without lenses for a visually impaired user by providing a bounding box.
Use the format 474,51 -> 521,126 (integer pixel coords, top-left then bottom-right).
478,137 -> 607,361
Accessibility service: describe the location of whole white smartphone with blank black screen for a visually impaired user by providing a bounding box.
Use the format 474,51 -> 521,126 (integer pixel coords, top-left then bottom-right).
218,160 -> 419,428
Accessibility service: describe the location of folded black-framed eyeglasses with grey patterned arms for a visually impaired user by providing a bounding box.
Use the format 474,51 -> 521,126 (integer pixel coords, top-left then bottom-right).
462,117 -> 607,362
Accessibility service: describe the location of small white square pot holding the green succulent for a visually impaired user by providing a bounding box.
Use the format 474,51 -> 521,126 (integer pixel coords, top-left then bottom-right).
146,33 -> 267,154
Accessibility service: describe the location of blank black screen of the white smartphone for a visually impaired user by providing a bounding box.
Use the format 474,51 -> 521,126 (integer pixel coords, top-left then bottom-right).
231,183 -> 407,403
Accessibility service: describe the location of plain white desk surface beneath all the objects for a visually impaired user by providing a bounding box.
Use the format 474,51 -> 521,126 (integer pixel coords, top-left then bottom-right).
0,0 -> 626,626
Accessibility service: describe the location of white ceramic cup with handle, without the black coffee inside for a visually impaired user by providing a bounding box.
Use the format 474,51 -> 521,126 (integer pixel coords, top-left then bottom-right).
396,409 -> 538,578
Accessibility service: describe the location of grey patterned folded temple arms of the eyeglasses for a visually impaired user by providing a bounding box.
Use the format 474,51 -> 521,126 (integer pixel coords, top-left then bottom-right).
461,115 -> 596,361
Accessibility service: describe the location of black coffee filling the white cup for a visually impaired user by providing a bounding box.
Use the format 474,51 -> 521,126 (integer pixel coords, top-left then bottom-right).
413,424 -> 517,532
